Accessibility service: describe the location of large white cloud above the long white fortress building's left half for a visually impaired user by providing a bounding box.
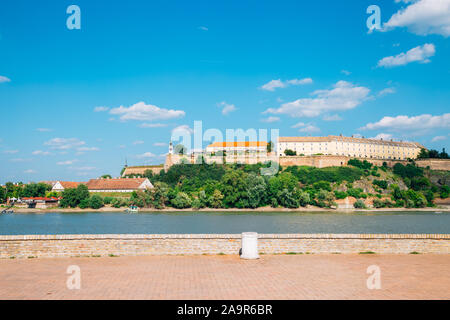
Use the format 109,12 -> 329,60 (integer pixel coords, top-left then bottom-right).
264,80 -> 370,117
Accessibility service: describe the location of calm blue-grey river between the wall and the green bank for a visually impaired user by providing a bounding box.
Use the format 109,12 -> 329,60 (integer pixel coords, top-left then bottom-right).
0,211 -> 450,235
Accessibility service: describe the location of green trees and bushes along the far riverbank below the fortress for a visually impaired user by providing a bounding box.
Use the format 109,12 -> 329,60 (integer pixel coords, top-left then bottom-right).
3,159 -> 450,209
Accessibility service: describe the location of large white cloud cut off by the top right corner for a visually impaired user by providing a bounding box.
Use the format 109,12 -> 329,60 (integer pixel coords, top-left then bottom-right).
383,0 -> 450,37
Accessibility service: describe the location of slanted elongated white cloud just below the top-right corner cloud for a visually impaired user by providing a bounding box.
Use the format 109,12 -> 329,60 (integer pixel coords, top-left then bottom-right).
378,43 -> 436,68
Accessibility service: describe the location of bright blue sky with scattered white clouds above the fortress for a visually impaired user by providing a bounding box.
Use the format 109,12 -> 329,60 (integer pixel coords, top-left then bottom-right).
0,0 -> 450,183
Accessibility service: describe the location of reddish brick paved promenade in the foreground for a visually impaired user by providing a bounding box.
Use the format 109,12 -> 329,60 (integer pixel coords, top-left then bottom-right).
0,254 -> 450,299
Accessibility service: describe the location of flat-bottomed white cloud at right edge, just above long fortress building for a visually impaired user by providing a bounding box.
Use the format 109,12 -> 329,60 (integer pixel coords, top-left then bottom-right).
362,113 -> 450,131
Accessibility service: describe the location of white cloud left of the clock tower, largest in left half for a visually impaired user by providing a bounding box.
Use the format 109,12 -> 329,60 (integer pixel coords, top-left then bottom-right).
109,102 -> 186,121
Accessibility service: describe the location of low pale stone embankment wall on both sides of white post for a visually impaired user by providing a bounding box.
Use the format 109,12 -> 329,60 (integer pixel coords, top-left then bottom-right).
0,234 -> 450,259
